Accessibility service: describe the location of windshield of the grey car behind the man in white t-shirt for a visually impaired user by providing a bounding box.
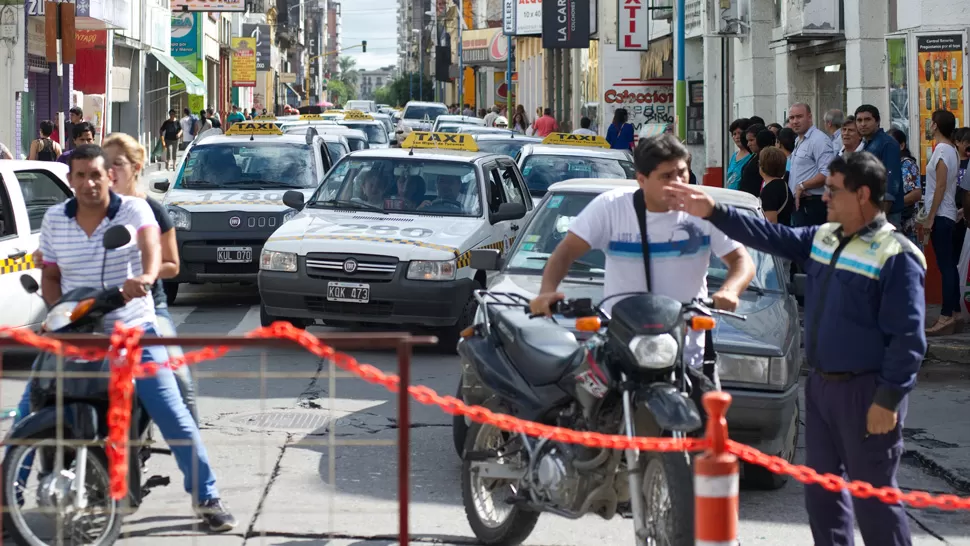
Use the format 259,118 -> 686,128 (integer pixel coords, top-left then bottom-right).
508,192 -> 782,291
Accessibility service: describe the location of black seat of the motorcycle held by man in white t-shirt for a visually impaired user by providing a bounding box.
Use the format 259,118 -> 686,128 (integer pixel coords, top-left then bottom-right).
492,308 -> 586,387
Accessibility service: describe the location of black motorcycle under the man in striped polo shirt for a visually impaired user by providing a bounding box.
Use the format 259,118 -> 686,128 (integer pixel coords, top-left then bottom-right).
2,226 -> 161,546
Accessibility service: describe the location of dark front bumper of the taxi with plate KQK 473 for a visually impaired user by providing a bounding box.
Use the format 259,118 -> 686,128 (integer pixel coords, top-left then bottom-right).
258,257 -> 478,328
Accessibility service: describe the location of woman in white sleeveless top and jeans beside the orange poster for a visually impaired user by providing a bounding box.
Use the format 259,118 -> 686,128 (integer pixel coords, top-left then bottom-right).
922,110 -> 963,336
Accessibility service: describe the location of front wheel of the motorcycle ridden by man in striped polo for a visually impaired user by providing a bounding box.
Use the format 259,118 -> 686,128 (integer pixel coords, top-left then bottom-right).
2,435 -> 124,546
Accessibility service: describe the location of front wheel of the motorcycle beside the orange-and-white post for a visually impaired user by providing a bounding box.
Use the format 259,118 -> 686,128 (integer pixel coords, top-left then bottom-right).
640,452 -> 694,546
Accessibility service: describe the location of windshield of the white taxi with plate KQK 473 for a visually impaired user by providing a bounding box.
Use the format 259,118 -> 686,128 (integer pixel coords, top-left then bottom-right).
307,156 -> 482,217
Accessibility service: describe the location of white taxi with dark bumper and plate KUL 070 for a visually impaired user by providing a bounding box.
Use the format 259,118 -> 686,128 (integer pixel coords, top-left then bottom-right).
152,121 -> 331,303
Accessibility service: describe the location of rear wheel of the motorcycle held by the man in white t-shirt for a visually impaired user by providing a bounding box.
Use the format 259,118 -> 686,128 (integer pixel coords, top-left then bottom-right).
461,408 -> 539,546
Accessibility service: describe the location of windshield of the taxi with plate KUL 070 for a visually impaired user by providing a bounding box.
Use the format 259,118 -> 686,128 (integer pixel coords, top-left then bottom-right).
174,140 -> 322,190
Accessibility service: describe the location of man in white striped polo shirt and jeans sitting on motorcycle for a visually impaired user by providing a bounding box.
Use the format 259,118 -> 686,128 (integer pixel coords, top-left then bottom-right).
30,145 -> 236,531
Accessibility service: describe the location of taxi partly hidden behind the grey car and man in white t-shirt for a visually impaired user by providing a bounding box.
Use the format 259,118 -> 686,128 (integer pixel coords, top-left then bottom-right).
516,133 -> 636,203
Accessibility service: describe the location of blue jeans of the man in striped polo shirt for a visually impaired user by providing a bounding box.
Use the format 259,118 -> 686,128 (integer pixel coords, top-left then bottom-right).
14,324 -> 219,502
